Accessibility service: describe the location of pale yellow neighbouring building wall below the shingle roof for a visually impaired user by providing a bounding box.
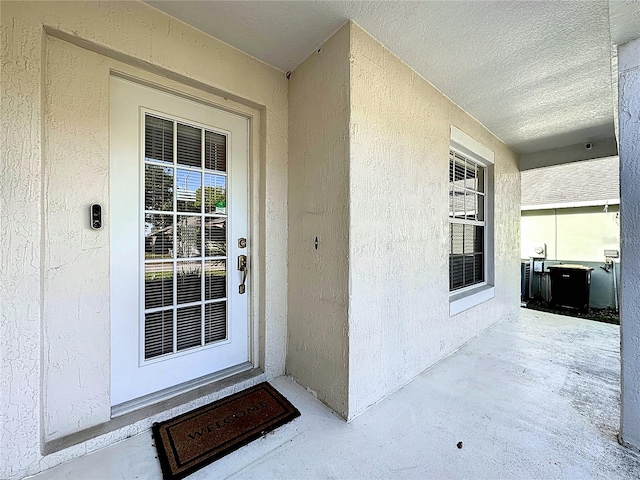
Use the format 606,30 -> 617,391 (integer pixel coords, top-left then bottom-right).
520,205 -> 620,262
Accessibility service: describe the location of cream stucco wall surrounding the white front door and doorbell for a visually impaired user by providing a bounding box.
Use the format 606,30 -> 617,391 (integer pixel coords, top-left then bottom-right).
0,2 -> 287,478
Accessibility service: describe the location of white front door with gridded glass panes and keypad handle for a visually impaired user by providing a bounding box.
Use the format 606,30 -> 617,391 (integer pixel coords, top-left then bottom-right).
110,76 -> 250,406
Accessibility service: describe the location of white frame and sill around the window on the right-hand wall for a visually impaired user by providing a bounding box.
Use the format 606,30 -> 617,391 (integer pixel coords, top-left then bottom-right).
447,125 -> 495,316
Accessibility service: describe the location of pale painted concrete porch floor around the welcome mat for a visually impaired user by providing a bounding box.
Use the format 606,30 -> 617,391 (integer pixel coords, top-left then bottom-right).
32,309 -> 640,480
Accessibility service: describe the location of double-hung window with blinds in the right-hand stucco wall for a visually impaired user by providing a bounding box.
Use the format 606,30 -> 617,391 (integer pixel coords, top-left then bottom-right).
449,150 -> 486,291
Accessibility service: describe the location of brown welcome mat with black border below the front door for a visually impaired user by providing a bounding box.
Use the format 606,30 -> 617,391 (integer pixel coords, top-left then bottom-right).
152,382 -> 300,480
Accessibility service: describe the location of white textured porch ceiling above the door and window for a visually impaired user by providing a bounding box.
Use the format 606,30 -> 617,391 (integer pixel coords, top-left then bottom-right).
147,0 -> 614,154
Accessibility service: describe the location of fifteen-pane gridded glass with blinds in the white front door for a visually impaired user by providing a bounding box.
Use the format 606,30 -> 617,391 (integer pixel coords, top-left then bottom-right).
142,114 -> 228,360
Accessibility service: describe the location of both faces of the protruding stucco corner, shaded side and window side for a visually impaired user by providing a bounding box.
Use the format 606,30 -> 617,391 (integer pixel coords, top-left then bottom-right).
287,23 -> 520,419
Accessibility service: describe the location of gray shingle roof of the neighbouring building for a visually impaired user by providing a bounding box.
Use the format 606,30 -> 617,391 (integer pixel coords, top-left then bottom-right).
520,157 -> 620,207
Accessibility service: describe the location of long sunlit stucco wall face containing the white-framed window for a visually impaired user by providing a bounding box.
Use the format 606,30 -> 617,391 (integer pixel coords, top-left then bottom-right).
348,25 -> 520,418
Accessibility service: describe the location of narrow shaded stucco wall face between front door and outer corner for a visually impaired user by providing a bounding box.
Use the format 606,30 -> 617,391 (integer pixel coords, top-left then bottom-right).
287,24 -> 350,417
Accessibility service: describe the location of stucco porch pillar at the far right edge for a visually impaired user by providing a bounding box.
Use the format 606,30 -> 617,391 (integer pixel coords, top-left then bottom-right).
618,38 -> 640,449
